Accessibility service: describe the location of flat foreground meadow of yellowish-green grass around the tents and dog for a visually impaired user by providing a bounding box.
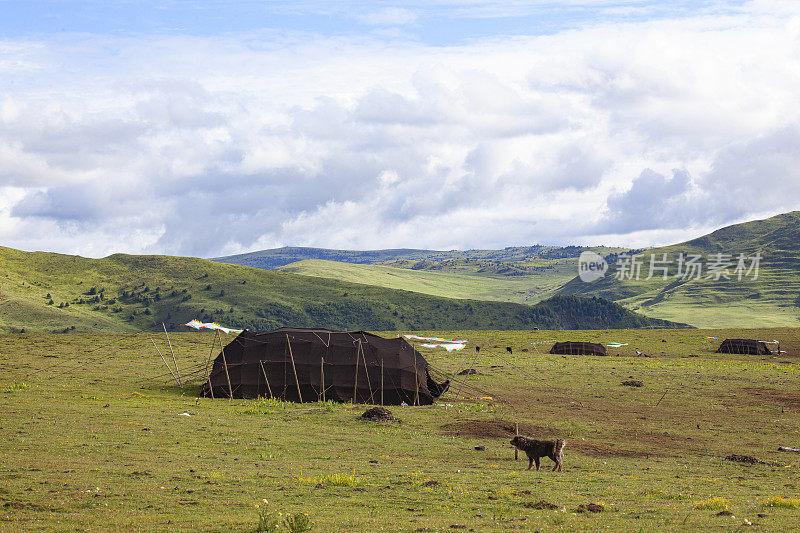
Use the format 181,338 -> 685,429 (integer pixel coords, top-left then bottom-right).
0,329 -> 800,531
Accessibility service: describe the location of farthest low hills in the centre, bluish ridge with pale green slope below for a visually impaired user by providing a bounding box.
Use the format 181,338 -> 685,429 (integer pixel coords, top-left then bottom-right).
223,245 -> 626,304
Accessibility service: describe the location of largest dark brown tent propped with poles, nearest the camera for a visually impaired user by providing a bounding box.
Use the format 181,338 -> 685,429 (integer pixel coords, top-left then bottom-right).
200,328 -> 449,405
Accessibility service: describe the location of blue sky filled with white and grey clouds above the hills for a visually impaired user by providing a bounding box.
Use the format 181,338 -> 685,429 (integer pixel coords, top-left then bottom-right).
0,0 -> 800,257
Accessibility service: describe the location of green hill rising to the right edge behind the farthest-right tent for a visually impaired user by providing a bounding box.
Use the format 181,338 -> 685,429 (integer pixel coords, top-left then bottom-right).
558,211 -> 800,327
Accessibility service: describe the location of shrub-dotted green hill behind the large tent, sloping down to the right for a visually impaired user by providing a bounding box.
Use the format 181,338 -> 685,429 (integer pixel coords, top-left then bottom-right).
0,247 -> 671,332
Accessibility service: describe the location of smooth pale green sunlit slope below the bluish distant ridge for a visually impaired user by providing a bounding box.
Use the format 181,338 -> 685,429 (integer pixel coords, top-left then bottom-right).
279,258 -> 578,304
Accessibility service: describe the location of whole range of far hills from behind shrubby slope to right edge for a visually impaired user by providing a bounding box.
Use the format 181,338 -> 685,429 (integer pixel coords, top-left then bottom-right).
211,211 -> 800,327
